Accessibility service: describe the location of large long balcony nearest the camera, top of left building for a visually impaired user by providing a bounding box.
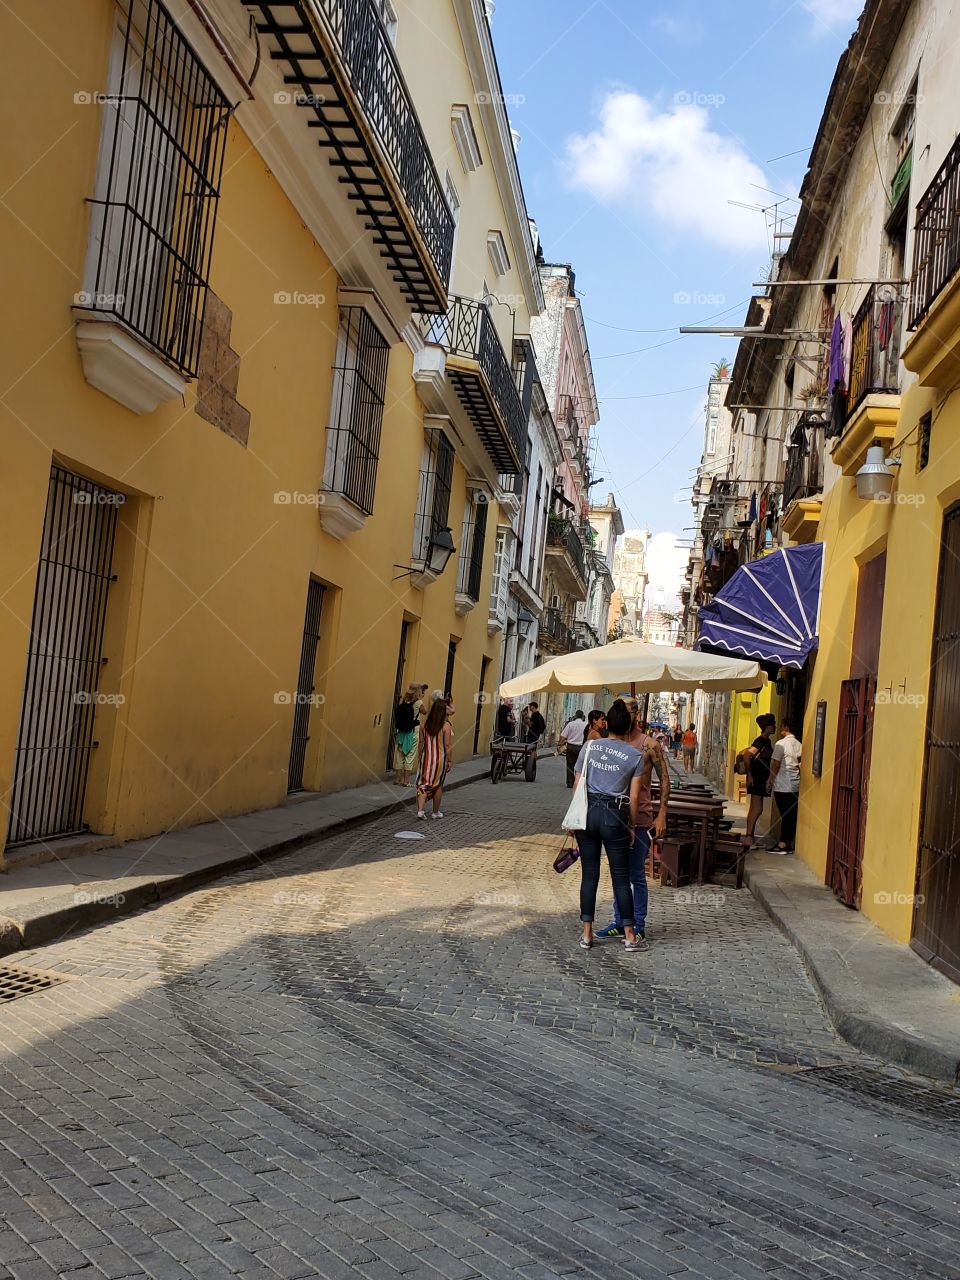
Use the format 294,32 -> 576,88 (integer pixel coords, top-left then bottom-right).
251,0 -> 453,312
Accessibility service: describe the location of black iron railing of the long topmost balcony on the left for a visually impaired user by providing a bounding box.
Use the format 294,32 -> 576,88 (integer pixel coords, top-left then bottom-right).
312,0 -> 453,283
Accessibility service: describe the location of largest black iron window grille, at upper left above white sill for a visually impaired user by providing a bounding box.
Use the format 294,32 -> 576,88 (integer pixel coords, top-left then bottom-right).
79,0 -> 230,376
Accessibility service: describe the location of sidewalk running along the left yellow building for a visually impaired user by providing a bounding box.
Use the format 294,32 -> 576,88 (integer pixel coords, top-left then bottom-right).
0,750 -> 512,956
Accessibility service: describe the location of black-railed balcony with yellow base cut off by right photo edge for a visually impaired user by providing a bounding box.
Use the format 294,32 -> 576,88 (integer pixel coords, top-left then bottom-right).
904,138 -> 960,390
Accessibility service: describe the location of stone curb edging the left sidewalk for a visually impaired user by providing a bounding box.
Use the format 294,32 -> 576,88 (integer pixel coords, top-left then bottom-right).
0,750 -> 554,956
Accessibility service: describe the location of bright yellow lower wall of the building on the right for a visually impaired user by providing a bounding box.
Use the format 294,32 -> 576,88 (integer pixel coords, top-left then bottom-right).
797,385 -> 960,942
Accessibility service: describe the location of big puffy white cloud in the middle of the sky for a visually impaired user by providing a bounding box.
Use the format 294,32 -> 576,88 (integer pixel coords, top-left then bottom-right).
567,90 -> 769,250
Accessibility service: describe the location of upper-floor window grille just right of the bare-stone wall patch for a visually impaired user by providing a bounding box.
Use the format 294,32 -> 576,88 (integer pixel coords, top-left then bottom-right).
324,307 -> 390,516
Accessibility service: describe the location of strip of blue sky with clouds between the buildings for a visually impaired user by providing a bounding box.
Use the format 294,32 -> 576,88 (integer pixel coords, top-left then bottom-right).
493,0 -> 860,604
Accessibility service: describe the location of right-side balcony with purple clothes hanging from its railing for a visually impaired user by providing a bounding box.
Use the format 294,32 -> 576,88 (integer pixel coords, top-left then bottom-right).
833,284 -> 904,475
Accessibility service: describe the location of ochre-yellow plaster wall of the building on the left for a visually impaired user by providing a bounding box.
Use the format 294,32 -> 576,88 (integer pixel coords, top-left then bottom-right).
0,0 -> 499,860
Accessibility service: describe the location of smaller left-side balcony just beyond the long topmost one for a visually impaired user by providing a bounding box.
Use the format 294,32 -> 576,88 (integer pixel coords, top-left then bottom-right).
415,294 -> 527,475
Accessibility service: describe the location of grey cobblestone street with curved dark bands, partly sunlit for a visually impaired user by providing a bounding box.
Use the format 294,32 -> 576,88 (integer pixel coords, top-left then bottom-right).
0,760 -> 960,1280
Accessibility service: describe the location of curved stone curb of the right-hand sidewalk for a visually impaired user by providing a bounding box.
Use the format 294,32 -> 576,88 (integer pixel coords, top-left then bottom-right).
744,860 -> 960,1087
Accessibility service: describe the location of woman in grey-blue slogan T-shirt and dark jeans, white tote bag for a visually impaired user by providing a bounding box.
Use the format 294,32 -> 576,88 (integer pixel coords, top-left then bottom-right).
575,699 -> 646,952
